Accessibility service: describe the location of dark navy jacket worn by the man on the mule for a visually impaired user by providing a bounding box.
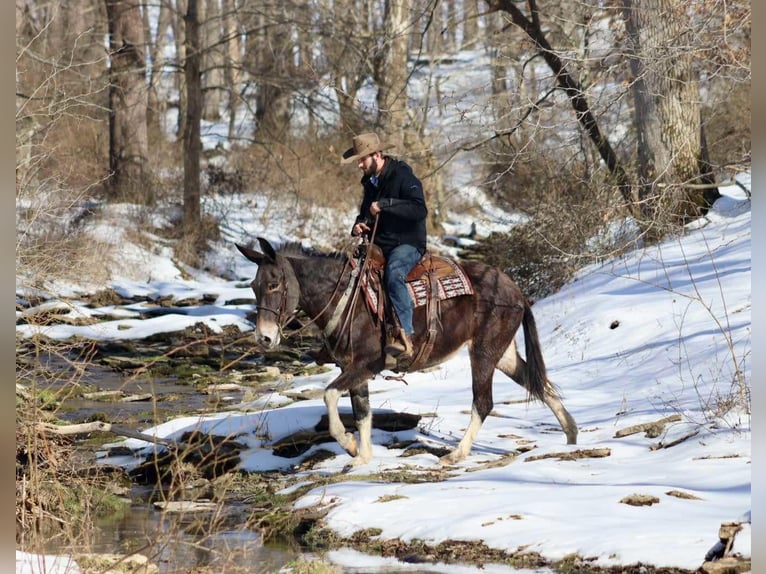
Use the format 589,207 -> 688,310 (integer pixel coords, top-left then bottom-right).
354,156 -> 428,256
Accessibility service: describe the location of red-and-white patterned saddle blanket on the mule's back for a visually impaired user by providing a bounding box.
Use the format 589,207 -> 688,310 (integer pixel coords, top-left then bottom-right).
362,253 -> 474,312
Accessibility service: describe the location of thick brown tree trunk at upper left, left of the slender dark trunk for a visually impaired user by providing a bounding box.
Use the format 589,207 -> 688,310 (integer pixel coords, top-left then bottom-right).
106,0 -> 151,203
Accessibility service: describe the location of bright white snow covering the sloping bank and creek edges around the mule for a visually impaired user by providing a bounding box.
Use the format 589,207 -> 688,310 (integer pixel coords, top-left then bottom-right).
17,174 -> 752,572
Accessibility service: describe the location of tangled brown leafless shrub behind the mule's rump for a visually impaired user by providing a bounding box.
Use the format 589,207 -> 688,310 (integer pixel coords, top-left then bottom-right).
461,153 -> 631,299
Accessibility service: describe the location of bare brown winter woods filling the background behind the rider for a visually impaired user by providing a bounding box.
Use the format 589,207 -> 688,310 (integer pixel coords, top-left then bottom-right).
15,0 -> 751,572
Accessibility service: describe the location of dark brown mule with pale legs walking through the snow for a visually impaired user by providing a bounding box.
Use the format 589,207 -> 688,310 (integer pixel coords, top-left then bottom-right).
237,237 -> 577,465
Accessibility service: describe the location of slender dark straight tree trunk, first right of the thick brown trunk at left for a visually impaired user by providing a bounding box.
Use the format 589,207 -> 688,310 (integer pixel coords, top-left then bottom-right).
183,0 -> 202,235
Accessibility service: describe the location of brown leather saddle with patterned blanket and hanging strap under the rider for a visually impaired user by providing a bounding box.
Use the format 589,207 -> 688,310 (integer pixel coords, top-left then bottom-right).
360,248 -> 474,365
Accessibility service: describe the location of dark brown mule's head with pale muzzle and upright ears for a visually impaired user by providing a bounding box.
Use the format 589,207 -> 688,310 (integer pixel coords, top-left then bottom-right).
236,237 -> 300,348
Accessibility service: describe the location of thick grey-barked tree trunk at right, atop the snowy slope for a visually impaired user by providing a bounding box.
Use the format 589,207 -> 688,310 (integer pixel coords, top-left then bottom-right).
622,0 -> 717,224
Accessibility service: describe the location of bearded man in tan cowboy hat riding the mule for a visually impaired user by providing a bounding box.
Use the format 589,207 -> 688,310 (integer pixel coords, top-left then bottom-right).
341,133 -> 428,360
